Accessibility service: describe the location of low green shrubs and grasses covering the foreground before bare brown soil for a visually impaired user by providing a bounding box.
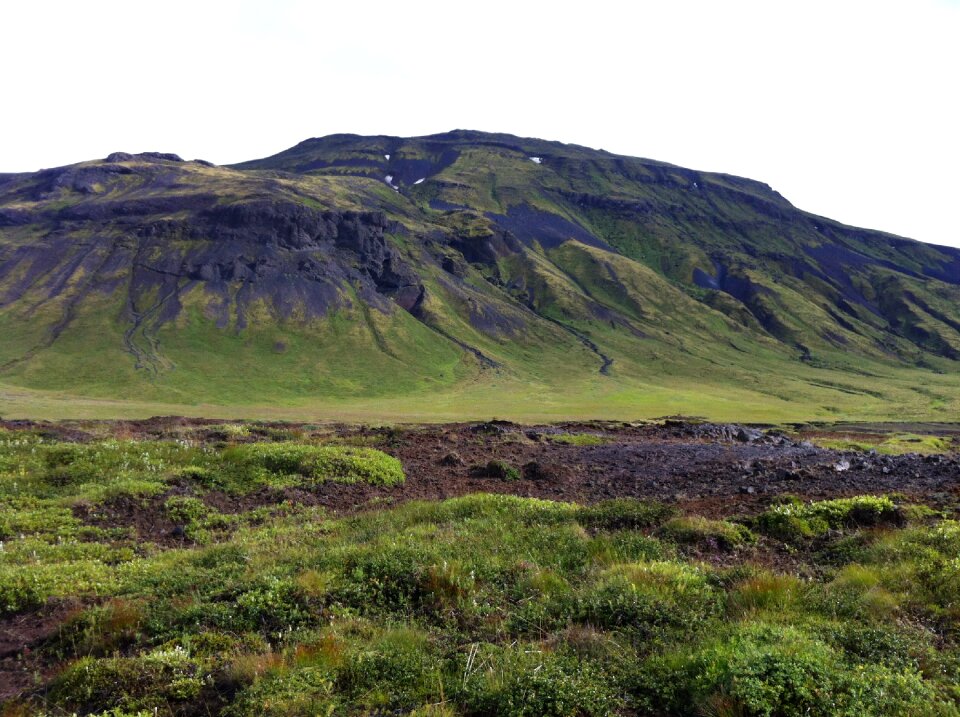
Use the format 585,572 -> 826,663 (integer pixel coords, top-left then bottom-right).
0,426 -> 960,717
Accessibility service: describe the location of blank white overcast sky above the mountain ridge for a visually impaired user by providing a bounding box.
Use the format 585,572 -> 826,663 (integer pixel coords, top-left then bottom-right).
0,0 -> 960,246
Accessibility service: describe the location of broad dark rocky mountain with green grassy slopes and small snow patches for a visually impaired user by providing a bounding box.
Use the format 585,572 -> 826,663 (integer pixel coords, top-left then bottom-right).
0,131 -> 960,420
